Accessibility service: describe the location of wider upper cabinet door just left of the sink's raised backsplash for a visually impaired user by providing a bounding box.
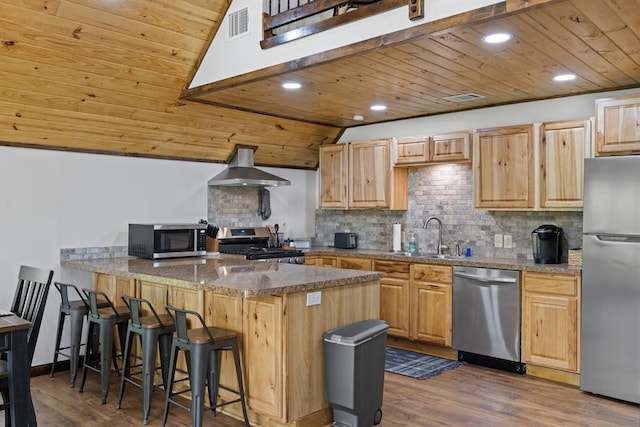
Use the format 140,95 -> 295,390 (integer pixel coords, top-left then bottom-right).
348,139 -> 391,208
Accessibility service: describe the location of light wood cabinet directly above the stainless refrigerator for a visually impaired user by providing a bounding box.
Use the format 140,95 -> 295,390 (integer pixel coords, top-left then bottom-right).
595,95 -> 640,156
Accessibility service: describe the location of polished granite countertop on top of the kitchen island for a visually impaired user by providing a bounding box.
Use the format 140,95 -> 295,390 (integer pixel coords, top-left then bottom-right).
60,255 -> 382,297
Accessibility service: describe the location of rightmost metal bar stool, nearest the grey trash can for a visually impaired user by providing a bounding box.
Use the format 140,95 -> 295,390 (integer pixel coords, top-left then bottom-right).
161,305 -> 249,427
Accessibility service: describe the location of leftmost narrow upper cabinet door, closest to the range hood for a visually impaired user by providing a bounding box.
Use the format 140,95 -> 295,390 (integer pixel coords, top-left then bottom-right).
320,144 -> 349,209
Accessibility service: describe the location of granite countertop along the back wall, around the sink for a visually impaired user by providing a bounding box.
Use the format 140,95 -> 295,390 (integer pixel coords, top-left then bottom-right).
305,246 -> 582,274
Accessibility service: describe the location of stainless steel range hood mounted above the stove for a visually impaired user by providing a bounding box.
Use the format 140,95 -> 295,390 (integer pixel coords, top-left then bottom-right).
208,145 -> 291,187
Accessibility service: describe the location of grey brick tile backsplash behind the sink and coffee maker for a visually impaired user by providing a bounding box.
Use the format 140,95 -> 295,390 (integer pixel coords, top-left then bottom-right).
314,164 -> 582,259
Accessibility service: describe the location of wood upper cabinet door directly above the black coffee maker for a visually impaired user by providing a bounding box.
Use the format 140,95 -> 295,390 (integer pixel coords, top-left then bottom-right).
539,120 -> 591,208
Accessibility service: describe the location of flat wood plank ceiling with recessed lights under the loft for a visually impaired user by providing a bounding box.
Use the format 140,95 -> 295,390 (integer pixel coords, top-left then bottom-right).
184,0 -> 640,130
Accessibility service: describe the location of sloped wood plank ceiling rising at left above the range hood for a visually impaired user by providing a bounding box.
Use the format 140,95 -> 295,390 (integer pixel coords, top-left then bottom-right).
0,0 -> 341,169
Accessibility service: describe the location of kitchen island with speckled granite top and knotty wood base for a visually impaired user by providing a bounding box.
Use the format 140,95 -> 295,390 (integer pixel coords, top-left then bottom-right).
61,256 -> 382,426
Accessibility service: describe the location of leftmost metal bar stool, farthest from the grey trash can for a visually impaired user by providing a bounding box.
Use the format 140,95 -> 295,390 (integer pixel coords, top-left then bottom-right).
49,282 -> 108,387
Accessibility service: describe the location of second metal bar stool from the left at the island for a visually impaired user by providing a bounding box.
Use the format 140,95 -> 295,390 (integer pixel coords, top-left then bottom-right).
80,289 -> 129,405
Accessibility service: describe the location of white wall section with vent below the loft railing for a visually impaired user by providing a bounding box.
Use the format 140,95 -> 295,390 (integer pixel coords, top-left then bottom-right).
189,0 -> 497,87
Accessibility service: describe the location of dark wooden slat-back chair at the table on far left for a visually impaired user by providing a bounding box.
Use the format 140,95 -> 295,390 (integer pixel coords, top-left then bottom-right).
0,265 -> 53,426
